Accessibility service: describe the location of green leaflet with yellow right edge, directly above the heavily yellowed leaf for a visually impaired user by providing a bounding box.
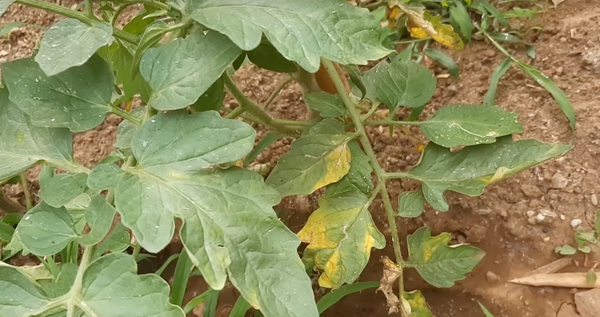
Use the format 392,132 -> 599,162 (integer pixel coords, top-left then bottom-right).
267,119 -> 350,196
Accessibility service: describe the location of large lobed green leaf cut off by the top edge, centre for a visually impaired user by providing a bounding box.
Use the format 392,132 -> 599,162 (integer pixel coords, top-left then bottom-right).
191,0 -> 390,73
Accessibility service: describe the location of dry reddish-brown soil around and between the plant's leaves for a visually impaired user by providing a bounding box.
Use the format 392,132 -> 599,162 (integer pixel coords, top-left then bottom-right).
0,0 -> 600,317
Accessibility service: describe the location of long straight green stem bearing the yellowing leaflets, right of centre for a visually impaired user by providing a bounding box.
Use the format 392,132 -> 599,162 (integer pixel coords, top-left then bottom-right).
321,59 -> 408,317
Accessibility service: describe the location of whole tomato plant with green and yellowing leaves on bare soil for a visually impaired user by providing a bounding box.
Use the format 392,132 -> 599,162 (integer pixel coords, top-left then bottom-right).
0,0 -> 571,317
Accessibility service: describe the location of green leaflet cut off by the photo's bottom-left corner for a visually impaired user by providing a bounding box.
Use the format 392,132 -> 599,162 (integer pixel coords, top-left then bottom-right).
0,266 -> 48,317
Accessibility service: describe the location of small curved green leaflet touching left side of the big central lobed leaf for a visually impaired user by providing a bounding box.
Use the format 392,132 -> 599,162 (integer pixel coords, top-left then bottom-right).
79,195 -> 116,246
